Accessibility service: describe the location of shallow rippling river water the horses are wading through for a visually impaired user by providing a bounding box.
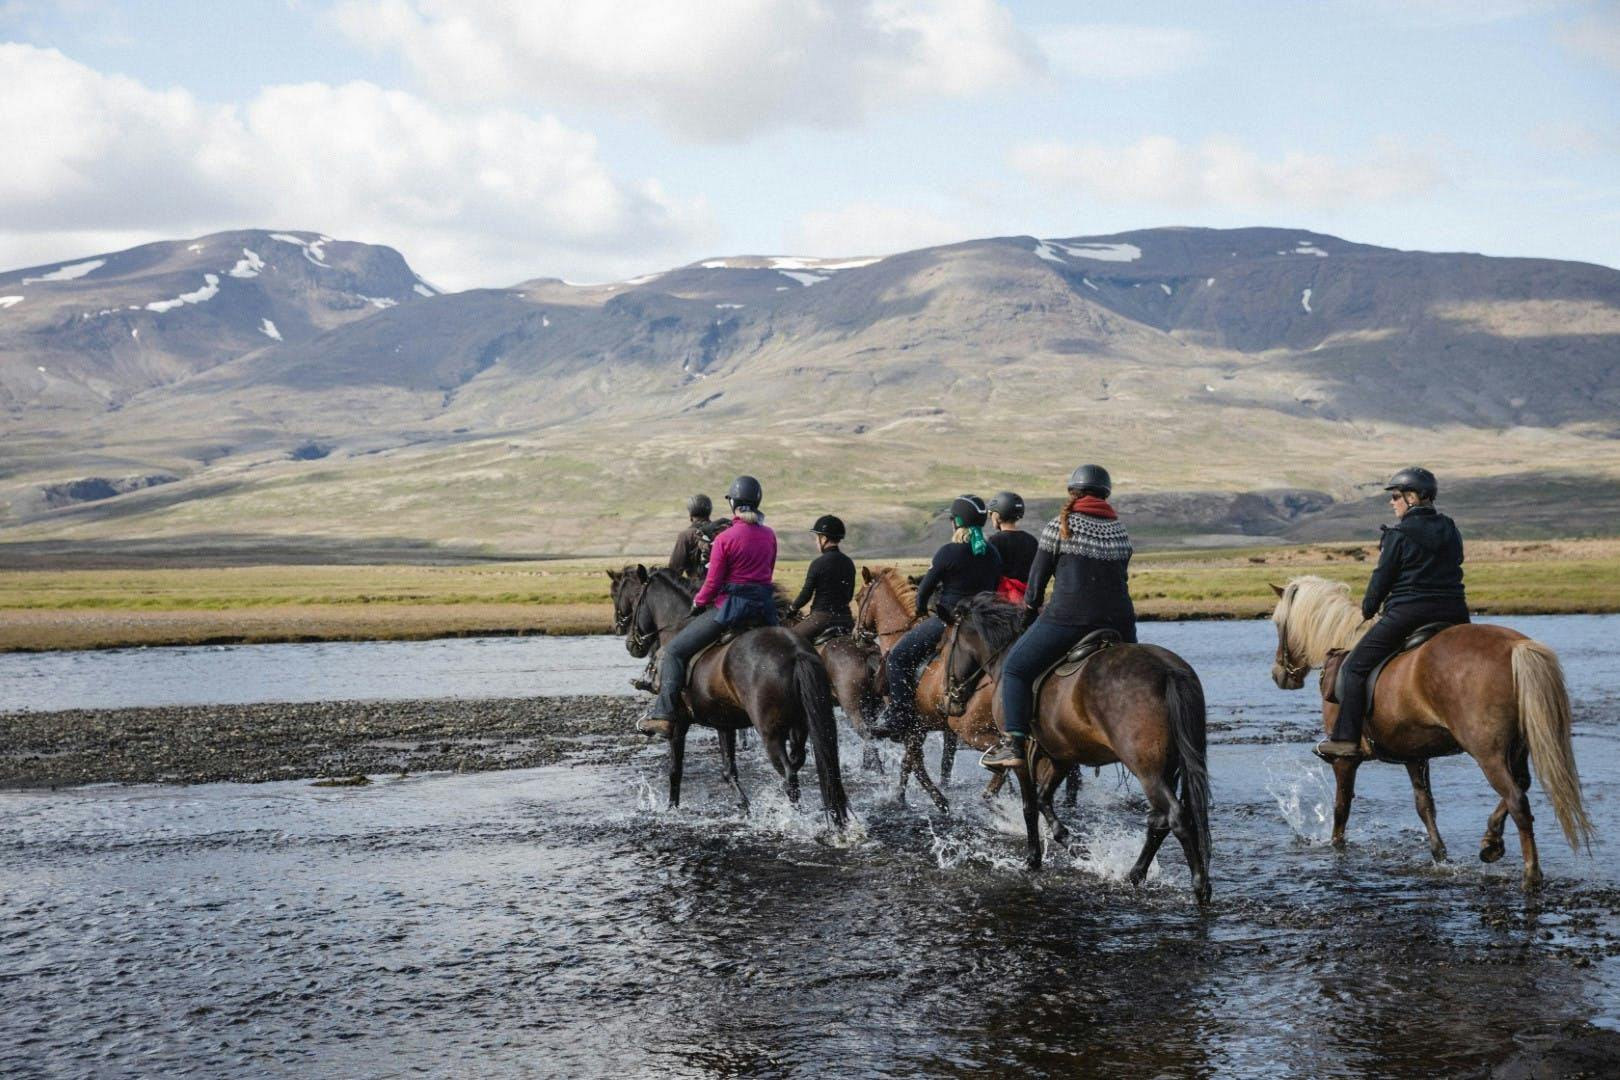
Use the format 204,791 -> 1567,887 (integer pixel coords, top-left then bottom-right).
0,617 -> 1620,1077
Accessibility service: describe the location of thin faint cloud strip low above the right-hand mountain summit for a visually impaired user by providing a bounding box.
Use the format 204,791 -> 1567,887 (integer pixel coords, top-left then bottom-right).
1013,136 -> 1442,209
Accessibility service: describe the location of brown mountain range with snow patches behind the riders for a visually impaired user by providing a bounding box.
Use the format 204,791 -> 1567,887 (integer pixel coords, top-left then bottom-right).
0,228 -> 1620,559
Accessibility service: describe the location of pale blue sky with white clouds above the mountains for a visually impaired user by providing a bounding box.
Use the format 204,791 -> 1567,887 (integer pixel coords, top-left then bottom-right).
0,0 -> 1620,288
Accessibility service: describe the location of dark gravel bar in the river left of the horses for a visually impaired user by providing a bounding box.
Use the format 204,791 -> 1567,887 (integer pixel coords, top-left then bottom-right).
0,696 -> 646,789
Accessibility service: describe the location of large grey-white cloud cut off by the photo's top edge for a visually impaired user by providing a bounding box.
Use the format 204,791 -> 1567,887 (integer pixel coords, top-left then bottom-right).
335,0 -> 1043,141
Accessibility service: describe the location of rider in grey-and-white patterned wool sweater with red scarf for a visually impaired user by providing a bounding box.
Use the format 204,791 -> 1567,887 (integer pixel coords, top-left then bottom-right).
980,465 -> 1136,769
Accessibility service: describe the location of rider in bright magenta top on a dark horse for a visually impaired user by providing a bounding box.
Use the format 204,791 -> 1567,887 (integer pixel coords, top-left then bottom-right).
635,476 -> 776,735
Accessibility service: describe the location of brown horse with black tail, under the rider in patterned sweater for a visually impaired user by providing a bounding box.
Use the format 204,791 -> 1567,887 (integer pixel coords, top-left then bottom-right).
944,593 -> 1210,904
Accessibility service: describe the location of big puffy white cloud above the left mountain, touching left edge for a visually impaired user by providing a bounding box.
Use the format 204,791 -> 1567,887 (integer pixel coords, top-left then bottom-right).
0,44 -> 705,287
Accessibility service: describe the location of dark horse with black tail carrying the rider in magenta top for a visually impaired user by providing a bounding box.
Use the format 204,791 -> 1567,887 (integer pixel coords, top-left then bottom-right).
625,567 -> 849,831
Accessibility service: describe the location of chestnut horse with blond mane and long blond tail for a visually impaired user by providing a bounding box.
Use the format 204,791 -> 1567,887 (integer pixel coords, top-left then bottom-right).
1272,575 -> 1592,891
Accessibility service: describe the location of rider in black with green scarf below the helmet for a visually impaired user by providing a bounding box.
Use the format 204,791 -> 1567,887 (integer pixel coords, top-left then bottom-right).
870,495 -> 1001,738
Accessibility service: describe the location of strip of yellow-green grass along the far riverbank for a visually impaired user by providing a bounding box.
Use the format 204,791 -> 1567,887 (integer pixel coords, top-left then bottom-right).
0,539 -> 1620,651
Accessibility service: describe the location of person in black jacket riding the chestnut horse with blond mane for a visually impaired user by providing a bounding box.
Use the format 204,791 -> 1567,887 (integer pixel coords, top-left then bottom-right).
1315,466 -> 1469,758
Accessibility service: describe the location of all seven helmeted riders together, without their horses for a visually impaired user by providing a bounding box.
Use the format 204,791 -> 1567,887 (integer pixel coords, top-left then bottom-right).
638,465 -> 1469,769
